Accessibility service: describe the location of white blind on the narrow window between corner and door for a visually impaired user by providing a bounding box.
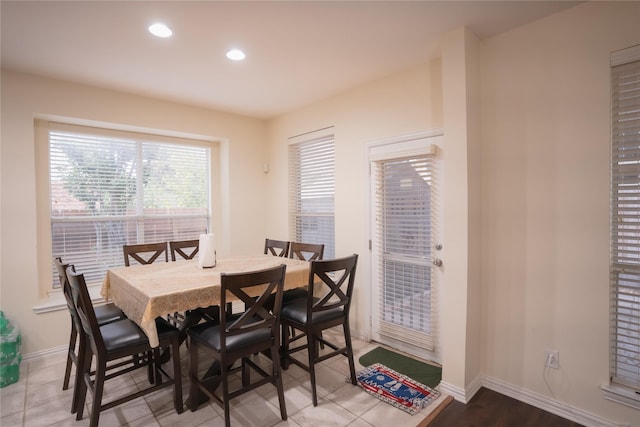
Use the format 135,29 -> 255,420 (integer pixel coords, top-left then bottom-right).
289,128 -> 335,259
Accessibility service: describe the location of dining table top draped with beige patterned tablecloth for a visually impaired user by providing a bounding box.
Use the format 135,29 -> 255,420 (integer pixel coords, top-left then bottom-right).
100,254 -> 310,347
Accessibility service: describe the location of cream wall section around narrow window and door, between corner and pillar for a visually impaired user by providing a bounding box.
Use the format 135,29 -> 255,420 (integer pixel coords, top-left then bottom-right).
266,59 -> 442,348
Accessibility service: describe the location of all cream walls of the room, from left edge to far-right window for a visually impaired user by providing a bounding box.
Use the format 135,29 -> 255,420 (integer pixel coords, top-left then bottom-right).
0,2 -> 640,426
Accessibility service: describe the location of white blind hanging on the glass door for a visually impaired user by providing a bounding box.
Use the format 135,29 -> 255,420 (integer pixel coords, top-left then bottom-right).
373,154 -> 434,350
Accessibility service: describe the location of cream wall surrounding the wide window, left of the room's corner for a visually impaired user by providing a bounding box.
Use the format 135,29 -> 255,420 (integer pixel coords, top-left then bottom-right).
0,70 -> 266,353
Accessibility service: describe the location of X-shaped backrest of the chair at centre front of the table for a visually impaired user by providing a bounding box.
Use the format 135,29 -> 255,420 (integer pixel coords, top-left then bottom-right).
220,264 -> 287,351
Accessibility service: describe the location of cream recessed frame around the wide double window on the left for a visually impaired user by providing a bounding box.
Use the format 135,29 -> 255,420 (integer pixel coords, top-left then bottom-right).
33,117 -> 223,304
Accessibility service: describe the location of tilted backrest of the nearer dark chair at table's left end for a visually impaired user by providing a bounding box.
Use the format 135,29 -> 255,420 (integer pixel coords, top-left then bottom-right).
67,265 -> 105,354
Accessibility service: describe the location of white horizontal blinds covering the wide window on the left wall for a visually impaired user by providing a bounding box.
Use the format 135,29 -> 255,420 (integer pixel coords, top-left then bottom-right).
48,123 -> 210,286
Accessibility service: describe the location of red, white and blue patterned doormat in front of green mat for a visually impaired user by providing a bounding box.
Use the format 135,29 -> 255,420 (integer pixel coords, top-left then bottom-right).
357,363 -> 440,415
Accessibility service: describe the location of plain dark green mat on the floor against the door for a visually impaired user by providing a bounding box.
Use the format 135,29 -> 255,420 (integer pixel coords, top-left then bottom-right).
359,347 -> 442,388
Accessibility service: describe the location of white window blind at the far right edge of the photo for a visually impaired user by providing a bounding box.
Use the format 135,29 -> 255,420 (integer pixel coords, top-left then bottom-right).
610,49 -> 640,392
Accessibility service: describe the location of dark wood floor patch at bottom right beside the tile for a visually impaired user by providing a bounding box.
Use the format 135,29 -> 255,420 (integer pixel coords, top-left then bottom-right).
429,387 -> 582,427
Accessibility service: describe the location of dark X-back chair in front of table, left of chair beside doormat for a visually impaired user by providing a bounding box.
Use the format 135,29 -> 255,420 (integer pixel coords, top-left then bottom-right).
189,264 -> 287,427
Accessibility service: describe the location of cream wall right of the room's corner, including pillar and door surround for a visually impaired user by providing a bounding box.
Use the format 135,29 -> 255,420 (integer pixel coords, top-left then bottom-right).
267,2 -> 640,425
